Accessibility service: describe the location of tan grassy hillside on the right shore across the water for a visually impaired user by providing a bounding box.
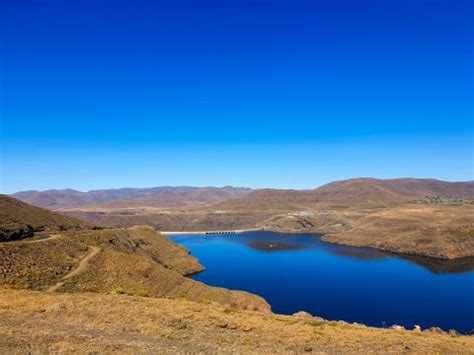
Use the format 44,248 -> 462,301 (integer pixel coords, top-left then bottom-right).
323,205 -> 474,259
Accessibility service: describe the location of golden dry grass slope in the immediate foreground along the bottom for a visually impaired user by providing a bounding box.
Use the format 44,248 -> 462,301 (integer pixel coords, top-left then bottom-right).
0,289 -> 474,354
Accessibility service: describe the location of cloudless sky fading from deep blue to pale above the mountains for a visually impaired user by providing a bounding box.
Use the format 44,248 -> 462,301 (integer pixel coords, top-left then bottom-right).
0,0 -> 474,193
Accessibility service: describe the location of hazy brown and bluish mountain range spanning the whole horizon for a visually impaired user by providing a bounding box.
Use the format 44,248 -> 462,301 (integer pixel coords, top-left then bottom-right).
12,178 -> 474,210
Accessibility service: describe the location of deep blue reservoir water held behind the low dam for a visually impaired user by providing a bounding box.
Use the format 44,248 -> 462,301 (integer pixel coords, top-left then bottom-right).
171,232 -> 474,333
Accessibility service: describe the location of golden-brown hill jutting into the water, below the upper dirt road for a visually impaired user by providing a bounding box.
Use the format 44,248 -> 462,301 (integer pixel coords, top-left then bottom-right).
0,227 -> 270,312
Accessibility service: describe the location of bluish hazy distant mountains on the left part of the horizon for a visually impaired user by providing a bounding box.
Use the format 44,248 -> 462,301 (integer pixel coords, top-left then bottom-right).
11,186 -> 252,209
